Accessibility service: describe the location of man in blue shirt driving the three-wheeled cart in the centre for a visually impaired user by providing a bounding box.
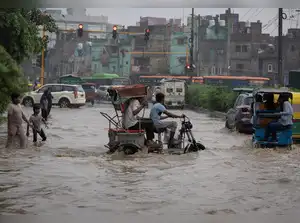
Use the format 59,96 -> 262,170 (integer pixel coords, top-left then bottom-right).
150,93 -> 185,148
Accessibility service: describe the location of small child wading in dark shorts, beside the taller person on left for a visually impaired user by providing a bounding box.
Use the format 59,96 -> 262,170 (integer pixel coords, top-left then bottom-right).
26,105 -> 47,143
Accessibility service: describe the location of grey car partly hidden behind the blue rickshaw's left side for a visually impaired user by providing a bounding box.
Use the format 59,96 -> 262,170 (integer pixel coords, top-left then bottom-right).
225,92 -> 253,134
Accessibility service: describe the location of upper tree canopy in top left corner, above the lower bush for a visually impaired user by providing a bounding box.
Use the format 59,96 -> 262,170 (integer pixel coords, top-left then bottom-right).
0,8 -> 57,64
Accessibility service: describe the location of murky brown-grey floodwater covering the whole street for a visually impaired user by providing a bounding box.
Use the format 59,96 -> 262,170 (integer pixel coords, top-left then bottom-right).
0,104 -> 300,217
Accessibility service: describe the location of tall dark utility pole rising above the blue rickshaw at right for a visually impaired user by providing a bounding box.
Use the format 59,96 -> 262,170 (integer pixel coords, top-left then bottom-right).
278,8 -> 284,86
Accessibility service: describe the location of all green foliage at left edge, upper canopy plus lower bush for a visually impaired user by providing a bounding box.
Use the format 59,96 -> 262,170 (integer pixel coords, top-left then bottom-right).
0,8 -> 57,116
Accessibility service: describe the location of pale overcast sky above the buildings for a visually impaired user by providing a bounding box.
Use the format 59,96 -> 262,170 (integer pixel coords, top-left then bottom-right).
58,8 -> 300,35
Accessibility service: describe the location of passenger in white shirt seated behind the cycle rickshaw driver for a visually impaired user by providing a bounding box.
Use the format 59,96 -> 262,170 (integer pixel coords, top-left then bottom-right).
123,98 -> 155,147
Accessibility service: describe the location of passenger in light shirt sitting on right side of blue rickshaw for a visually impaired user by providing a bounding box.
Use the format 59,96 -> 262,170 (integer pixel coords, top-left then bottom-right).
265,95 -> 294,141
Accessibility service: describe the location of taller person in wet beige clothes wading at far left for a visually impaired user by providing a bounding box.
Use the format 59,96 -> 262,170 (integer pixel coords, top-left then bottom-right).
6,93 -> 31,149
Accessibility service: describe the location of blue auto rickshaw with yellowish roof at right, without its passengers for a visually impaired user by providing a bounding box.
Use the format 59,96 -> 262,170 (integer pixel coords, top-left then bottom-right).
252,88 -> 293,148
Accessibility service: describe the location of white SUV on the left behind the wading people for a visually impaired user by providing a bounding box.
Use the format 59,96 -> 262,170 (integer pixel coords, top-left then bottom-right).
22,84 -> 86,108
